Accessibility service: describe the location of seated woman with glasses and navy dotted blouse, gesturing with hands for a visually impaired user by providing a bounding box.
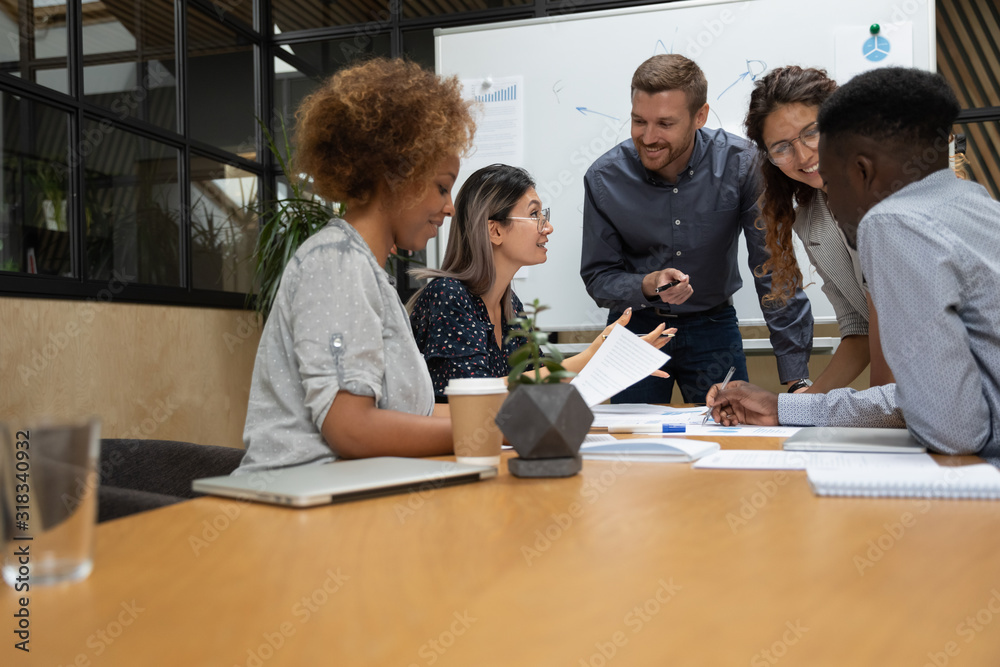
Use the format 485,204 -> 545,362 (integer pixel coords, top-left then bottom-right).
408,164 -> 674,402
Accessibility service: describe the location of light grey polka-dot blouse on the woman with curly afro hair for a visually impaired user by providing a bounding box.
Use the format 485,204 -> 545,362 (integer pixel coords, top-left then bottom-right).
233,218 -> 434,475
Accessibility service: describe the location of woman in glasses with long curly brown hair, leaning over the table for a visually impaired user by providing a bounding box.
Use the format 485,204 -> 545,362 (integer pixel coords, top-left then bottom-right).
745,66 -> 892,392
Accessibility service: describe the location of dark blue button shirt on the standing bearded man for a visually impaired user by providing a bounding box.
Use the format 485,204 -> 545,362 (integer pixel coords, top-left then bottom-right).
580,128 -> 813,382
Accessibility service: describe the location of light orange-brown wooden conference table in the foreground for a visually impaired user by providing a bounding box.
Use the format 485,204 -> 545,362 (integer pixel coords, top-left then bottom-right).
7,430 -> 1000,667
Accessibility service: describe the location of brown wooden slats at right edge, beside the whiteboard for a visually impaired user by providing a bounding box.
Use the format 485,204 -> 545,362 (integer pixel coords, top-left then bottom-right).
937,0 -> 1000,199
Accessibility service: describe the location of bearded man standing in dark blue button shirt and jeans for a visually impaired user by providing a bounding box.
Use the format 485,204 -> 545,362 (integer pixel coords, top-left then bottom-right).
580,55 -> 813,403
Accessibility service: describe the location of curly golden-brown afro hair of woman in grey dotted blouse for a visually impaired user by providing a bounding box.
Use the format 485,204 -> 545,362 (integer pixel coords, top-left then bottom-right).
295,58 -> 476,204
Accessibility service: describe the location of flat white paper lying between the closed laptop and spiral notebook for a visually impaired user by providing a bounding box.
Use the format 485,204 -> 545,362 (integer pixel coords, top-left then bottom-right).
693,449 -> 938,470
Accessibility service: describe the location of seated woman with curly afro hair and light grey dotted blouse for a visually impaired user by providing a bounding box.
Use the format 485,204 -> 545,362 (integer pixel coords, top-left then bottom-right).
237,59 -> 475,474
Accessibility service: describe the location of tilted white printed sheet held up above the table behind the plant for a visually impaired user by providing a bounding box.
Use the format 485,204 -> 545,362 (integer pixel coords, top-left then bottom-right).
573,324 -> 670,408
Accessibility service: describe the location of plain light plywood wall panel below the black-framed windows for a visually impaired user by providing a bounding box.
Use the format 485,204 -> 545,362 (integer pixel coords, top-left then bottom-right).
0,298 -> 260,447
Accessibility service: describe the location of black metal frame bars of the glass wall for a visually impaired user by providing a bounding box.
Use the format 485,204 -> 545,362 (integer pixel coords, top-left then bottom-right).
0,0 -> 1000,309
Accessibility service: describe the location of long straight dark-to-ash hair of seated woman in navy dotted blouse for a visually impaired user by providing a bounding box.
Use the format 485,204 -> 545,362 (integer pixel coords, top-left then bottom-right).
407,164 -> 535,320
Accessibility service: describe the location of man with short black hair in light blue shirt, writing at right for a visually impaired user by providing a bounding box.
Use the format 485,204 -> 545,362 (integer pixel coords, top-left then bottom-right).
708,67 -> 1000,462
